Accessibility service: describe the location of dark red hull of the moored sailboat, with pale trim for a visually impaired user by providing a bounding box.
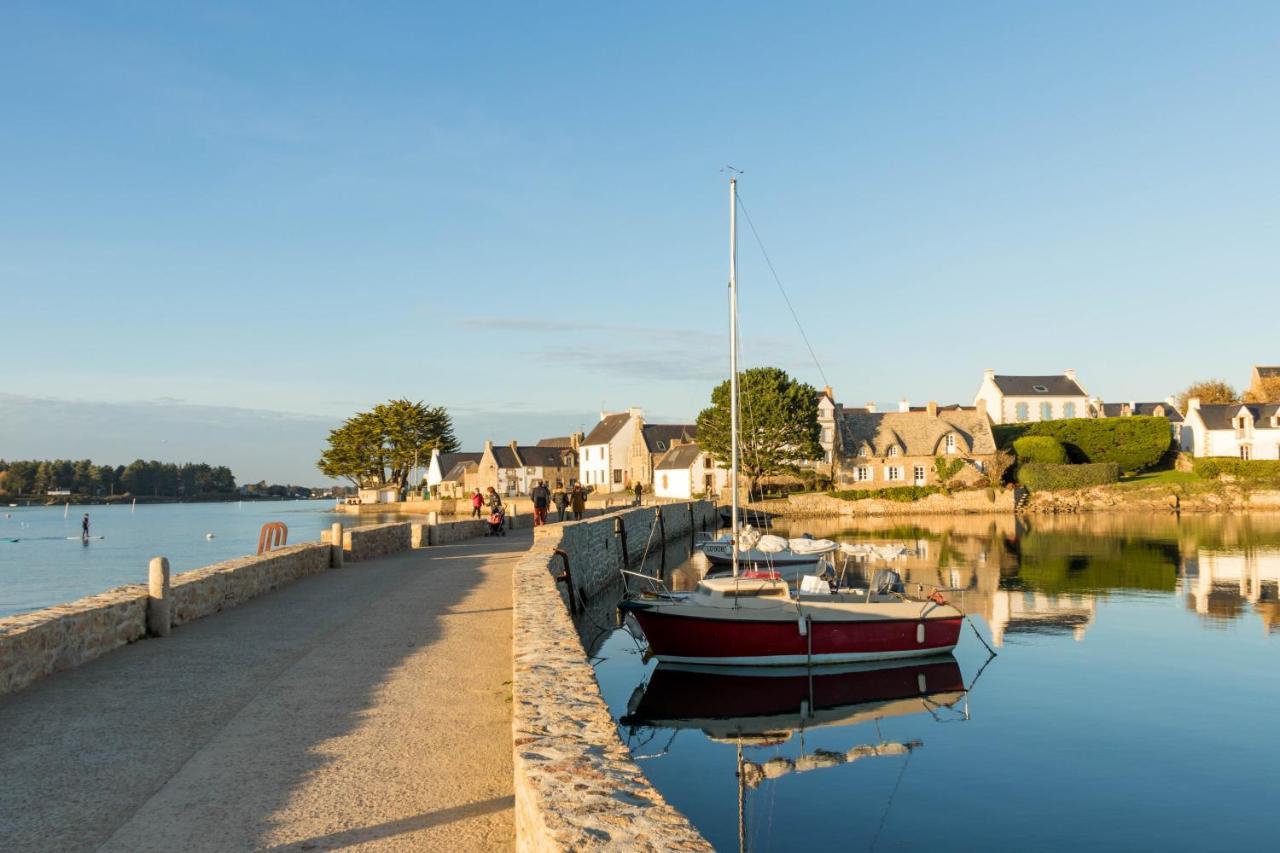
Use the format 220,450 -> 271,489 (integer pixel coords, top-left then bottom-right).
623,602 -> 963,666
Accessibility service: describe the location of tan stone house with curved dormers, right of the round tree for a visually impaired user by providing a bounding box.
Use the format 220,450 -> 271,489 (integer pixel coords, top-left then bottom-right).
836,402 -> 996,489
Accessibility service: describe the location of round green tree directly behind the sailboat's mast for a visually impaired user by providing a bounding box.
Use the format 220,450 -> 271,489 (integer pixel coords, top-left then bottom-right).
698,368 -> 822,492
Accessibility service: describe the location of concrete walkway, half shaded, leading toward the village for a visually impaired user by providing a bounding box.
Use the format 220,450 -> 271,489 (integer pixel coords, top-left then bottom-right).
0,530 -> 531,853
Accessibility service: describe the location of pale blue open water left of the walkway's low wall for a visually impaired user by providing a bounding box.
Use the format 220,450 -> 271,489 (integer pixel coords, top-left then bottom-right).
0,500 -> 404,616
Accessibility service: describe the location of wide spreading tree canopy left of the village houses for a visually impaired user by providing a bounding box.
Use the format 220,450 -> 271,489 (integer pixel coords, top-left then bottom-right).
316,400 -> 458,488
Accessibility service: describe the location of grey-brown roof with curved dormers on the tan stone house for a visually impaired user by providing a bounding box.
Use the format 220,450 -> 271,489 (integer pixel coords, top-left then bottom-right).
840,409 -> 996,457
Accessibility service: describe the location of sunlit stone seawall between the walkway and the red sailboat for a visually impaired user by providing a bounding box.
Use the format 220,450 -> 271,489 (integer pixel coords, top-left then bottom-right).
512,501 -> 718,852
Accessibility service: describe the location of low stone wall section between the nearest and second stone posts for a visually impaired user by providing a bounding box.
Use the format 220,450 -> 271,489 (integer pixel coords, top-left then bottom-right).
169,543 -> 330,625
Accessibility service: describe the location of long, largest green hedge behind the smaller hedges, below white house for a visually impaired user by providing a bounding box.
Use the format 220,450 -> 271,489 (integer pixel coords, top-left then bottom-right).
995,415 -> 1172,471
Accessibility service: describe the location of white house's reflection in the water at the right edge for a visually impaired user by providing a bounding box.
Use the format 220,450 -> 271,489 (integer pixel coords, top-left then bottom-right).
1181,547 -> 1280,633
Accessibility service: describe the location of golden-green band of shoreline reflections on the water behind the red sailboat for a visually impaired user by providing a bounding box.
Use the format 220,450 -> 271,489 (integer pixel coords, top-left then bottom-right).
671,515 -> 1280,646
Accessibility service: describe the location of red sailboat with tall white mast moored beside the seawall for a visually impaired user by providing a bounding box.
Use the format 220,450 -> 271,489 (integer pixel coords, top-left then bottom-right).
621,177 -> 964,666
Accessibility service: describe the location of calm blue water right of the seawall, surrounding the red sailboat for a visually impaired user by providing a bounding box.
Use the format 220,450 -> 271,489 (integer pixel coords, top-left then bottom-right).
584,516 -> 1280,850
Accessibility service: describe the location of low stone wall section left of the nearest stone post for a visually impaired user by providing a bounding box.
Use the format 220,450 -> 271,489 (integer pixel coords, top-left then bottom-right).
0,584 -> 147,695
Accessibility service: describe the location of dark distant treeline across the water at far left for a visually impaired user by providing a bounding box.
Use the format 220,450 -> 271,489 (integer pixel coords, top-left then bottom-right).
0,459 -> 237,497
